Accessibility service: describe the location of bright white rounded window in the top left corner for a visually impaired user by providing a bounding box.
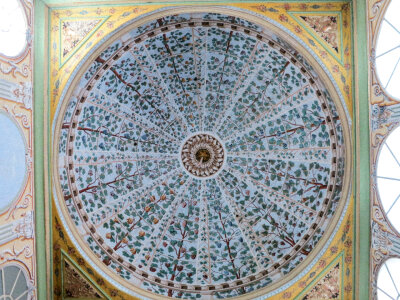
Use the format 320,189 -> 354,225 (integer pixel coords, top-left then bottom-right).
0,0 -> 28,57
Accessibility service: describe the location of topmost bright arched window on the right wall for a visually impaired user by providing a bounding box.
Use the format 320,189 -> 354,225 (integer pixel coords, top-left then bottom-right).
375,1 -> 400,99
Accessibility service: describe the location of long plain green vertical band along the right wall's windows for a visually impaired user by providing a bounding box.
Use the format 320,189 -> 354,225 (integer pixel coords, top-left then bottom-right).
353,0 -> 370,300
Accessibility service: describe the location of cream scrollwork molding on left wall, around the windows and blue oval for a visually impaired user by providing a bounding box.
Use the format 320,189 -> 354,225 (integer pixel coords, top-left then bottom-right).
0,0 -> 36,300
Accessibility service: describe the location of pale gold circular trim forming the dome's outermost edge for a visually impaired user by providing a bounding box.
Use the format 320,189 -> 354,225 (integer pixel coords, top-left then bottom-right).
51,4 -> 353,299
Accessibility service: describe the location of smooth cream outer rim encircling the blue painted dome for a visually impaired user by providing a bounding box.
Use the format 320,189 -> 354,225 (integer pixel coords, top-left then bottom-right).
52,6 -> 352,299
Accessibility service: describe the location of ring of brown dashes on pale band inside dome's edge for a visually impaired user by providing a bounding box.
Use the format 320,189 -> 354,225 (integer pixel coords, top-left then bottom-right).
61,21 -> 338,292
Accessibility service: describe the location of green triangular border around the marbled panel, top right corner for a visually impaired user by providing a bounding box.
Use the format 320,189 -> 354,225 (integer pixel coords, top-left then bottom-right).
287,11 -> 343,66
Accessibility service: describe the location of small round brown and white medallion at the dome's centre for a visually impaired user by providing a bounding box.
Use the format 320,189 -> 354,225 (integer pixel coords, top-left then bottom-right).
181,133 -> 224,178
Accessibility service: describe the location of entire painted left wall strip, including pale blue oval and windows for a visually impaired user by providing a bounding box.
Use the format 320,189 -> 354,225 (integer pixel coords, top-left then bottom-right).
0,0 -> 37,299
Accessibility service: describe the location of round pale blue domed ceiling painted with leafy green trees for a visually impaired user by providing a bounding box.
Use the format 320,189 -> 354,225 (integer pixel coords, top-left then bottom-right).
56,13 -> 348,299
